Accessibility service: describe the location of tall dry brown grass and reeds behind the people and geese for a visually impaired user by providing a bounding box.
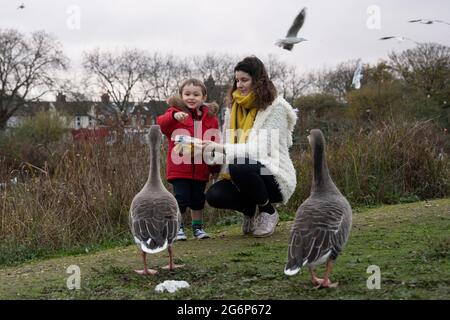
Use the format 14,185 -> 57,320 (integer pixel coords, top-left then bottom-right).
0,119 -> 450,267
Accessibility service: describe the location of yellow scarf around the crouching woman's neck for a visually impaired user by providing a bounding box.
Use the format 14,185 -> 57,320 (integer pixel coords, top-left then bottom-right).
220,90 -> 258,180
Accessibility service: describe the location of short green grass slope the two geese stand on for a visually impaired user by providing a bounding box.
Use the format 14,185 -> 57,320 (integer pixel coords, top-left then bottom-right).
0,199 -> 450,300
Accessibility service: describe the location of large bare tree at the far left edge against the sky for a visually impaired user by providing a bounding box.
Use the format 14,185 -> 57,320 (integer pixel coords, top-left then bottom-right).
0,29 -> 69,130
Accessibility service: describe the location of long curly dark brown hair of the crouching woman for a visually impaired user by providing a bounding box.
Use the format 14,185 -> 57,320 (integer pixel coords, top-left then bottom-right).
225,56 -> 277,110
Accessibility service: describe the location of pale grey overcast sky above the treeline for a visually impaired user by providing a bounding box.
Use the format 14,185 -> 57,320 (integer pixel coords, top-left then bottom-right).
0,0 -> 450,71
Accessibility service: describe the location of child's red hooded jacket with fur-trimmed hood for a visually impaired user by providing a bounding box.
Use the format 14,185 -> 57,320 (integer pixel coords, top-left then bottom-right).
156,97 -> 220,181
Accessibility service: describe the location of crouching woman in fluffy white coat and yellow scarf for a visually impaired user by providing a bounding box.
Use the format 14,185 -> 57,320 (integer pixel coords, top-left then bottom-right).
203,56 -> 297,237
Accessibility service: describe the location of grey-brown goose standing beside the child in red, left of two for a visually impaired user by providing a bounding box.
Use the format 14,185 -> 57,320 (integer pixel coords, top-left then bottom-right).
130,125 -> 180,275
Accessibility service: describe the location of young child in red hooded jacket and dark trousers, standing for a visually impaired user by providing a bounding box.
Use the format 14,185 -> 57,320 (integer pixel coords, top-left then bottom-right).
156,79 -> 220,240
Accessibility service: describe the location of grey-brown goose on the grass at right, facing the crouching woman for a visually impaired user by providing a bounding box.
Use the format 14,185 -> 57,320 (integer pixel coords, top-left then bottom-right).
284,129 -> 352,288
